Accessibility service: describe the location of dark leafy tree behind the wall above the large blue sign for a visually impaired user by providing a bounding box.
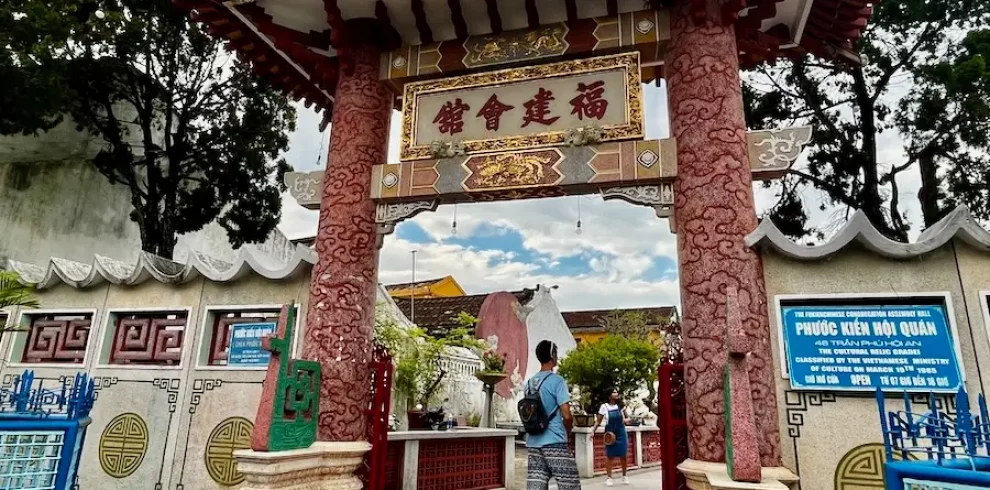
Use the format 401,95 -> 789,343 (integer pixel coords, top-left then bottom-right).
743,0 -> 990,241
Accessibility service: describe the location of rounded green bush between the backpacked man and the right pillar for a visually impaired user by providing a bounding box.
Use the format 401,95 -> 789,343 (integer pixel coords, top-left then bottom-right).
560,335 -> 660,413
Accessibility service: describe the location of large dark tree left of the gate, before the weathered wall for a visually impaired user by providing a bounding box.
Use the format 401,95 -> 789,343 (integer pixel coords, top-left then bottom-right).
0,0 -> 295,258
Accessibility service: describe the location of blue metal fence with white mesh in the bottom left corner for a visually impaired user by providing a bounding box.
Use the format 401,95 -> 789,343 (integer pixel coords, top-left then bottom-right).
0,371 -> 95,490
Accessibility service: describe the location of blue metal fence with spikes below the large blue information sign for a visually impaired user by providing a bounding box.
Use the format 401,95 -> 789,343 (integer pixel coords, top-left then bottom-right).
876,388 -> 990,490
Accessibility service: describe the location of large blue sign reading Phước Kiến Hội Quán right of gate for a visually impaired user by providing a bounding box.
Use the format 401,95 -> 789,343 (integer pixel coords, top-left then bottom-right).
781,305 -> 962,392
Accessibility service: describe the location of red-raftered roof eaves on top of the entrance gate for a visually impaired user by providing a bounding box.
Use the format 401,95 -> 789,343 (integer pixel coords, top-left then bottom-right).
173,0 -> 876,121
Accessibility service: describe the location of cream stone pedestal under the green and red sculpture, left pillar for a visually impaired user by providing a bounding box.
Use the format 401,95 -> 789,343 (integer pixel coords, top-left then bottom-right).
234,442 -> 371,490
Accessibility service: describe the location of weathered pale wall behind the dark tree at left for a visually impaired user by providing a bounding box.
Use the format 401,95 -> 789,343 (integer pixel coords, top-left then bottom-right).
0,110 -> 294,266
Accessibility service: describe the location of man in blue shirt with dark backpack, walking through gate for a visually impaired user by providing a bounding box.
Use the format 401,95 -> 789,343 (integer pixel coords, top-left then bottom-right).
524,340 -> 581,490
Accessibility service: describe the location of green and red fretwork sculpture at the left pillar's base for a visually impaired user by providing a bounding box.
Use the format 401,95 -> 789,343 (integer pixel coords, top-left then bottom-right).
251,305 -> 321,451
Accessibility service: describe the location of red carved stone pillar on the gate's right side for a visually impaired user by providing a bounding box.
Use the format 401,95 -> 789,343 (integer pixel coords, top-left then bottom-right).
664,0 -> 781,467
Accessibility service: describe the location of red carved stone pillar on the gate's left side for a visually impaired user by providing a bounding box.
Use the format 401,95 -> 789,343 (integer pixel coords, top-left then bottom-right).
303,36 -> 394,441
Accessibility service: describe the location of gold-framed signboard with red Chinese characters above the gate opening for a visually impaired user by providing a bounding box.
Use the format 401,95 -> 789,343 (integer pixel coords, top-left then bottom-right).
400,52 -> 643,160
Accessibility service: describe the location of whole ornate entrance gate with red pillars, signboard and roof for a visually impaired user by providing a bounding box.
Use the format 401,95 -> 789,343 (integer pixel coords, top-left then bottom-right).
177,0 -> 872,484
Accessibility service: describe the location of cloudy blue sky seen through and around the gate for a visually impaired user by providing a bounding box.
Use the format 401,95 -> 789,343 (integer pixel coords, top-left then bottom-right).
279,85 -> 920,311
